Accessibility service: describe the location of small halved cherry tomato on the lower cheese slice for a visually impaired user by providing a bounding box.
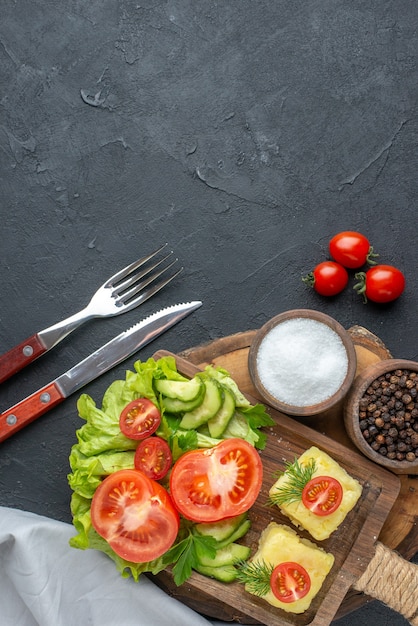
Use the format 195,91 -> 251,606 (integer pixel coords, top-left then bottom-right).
270,561 -> 311,604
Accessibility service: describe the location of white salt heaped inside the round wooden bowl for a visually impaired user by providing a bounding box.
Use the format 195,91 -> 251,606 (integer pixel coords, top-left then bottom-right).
257,318 -> 348,407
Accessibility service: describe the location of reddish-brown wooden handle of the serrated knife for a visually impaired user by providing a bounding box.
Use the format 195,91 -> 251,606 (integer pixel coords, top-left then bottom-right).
0,381 -> 65,441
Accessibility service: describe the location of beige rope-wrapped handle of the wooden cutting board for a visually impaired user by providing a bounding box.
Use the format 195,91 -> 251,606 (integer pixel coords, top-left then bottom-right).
354,542 -> 418,626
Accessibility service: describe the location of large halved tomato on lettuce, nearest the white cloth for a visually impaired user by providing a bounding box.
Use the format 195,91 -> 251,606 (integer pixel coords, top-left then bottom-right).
91,470 -> 179,563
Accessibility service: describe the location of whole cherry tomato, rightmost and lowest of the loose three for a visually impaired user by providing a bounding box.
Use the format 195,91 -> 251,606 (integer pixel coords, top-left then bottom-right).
354,265 -> 405,303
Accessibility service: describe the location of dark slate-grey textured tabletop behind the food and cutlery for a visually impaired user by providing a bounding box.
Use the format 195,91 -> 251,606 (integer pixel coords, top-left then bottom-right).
0,0 -> 418,626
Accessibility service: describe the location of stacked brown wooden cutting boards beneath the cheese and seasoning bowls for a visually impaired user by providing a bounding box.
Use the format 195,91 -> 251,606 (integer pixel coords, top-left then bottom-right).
149,326 -> 418,626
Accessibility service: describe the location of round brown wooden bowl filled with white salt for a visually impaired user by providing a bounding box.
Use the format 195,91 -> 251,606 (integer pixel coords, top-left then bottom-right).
248,309 -> 357,417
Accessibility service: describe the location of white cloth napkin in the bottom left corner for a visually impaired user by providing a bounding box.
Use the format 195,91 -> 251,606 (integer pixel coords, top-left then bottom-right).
0,507 -> 247,626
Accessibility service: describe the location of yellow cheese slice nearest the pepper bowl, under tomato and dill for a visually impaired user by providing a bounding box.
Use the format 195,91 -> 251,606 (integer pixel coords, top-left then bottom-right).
269,446 -> 362,541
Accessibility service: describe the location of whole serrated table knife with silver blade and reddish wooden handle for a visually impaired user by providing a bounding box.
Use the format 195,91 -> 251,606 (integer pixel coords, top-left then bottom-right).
0,300 -> 202,442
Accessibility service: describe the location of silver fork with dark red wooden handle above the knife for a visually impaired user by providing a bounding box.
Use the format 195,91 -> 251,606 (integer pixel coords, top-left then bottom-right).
0,244 -> 183,383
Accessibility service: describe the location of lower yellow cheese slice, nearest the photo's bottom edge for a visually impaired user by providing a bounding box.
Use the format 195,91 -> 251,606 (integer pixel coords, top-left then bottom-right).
245,522 -> 334,613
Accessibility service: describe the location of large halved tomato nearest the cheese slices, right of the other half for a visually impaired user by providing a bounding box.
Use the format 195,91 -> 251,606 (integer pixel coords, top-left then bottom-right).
170,439 -> 263,522
